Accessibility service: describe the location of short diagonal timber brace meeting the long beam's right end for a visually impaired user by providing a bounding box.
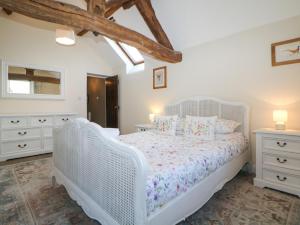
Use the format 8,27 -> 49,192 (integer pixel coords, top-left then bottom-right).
135,0 -> 173,49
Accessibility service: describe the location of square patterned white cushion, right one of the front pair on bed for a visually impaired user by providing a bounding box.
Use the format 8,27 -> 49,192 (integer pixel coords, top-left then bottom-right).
184,116 -> 217,141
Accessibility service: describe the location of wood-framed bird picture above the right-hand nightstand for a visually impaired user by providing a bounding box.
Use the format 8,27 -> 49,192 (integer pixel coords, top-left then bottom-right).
272,38 -> 300,66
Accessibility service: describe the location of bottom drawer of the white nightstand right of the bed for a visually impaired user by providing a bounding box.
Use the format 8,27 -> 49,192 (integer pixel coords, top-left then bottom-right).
263,169 -> 300,188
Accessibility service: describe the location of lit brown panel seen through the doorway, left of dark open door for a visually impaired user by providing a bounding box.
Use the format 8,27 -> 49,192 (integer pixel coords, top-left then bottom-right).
87,76 -> 106,127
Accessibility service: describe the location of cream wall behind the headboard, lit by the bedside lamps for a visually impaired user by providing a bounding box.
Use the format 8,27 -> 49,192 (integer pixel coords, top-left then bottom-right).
120,16 -> 300,163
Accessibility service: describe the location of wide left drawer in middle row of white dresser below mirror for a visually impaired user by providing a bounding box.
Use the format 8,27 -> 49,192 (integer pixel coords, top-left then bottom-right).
1,129 -> 41,141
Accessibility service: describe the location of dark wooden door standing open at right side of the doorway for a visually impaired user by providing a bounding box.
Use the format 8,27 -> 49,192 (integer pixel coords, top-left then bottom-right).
105,76 -> 119,128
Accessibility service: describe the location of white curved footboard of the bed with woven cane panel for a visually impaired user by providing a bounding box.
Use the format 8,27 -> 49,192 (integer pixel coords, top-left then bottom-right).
53,120 -> 148,225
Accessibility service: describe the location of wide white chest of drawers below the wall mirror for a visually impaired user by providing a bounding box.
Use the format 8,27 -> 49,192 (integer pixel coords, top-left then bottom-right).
0,113 -> 76,161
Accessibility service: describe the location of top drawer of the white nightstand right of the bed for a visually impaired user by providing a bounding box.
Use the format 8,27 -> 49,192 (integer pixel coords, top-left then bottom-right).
263,138 -> 300,153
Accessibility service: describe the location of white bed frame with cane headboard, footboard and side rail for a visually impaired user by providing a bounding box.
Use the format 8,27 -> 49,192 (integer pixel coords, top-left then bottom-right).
53,97 -> 250,225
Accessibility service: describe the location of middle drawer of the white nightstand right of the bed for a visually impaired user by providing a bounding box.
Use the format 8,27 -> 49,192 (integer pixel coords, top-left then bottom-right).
263,153 -> 300,170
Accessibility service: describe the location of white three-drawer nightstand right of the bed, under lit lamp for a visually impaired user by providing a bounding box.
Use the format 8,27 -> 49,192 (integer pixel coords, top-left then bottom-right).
254,129 -> 300,197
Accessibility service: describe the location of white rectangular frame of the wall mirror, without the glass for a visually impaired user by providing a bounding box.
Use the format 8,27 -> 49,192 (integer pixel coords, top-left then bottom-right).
0,59 -> 65,100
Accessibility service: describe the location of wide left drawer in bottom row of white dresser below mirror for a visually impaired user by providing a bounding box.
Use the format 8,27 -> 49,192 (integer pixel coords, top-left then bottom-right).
1,139 -> 42,154
